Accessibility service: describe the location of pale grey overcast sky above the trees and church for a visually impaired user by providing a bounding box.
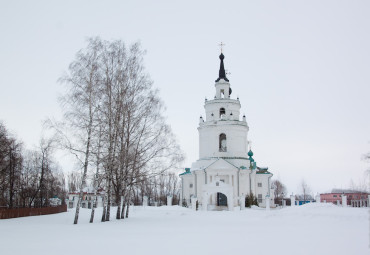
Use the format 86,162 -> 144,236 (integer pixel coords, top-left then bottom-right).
0,0 -> 370,193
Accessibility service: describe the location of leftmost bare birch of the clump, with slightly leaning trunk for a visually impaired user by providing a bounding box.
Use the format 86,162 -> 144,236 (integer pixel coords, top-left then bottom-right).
53,38 -> 101,224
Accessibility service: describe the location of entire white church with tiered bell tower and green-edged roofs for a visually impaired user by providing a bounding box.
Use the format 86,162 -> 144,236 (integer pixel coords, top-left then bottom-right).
180,52 -> 273,210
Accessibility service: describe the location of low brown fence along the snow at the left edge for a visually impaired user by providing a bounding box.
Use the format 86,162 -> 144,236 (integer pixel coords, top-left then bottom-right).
0,205 -> 67,219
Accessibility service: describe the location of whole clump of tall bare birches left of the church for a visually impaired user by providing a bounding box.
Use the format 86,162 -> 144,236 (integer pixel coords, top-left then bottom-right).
48,37 -> 183,224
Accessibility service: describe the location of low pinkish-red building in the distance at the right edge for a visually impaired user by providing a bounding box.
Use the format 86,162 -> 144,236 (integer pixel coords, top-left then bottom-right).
320,189 -> 370,207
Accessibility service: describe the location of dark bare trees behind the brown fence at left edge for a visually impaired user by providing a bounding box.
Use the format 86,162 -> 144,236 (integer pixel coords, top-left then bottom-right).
0,122 -> 66,208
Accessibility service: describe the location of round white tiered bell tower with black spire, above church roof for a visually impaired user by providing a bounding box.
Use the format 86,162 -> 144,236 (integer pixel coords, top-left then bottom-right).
198,52 -> 249,159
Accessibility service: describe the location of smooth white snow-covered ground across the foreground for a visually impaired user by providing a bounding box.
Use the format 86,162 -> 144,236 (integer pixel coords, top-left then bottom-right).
0,204 -> 370,255
